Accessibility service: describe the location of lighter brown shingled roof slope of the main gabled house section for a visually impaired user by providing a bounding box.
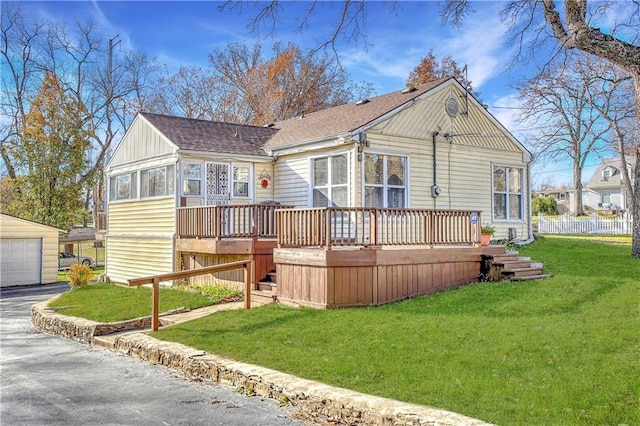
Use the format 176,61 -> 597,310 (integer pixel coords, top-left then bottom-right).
265,77 -> 450,149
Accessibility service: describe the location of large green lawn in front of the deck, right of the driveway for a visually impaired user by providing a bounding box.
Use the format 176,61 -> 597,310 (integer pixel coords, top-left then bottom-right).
153,236 -> 640,425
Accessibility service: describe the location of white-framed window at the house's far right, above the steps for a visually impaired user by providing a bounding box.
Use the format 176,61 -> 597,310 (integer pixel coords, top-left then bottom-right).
493,166 -> 524,220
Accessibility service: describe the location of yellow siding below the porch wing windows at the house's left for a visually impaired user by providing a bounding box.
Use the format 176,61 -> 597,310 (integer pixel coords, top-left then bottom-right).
106,196 -> 176,282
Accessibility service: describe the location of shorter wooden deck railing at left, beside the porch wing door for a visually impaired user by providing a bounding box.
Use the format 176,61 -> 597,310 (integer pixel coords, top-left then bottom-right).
177,204 -> 290,239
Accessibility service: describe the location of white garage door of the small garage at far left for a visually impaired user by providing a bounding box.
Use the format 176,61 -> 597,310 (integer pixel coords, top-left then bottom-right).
0,238 -> 42,287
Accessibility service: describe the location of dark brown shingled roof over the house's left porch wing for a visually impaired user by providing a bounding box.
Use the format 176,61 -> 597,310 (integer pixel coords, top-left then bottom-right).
140,112 -> 277,156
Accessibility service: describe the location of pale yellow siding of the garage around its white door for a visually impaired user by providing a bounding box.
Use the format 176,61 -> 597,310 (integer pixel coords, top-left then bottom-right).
0,214 -> 60,283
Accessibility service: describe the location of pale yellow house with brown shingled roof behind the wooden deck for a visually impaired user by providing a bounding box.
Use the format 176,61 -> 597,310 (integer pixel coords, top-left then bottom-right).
106,78 -> 532,306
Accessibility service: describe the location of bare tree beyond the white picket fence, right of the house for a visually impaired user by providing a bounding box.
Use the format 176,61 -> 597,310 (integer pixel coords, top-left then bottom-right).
520,54 -> 628,215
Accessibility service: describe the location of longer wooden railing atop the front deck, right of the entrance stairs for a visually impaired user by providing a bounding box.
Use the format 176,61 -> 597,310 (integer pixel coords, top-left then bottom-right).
275,207 -> 481,249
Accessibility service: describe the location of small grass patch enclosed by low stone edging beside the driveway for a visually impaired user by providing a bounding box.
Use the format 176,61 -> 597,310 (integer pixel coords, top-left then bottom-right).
49,283 -> 231,322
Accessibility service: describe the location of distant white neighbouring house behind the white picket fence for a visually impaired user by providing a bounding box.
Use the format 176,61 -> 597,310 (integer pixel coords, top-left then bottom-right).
582,159 -> 635,213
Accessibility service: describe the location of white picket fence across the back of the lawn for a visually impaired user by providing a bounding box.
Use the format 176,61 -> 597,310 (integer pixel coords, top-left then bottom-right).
538,213 -> 633,235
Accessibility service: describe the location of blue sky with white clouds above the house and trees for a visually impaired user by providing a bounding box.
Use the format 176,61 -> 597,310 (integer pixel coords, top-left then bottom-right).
16,1 -> 620,186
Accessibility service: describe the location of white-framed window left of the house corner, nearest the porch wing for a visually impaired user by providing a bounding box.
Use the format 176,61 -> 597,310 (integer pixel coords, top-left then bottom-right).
311,153 -> 349,207
